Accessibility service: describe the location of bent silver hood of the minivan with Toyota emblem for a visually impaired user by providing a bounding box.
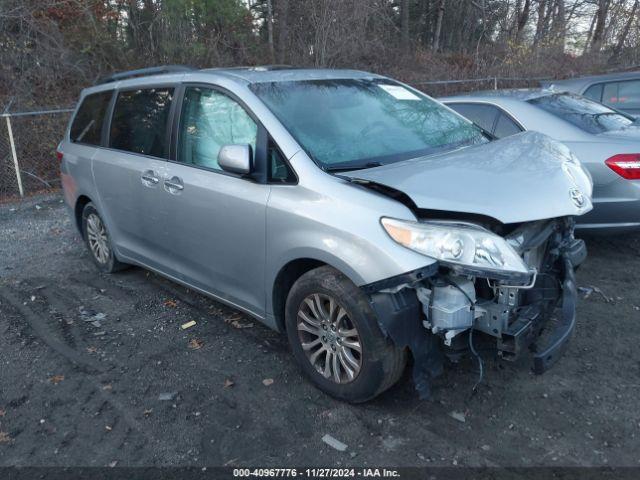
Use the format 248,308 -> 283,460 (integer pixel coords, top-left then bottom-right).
343,131 -> 593,223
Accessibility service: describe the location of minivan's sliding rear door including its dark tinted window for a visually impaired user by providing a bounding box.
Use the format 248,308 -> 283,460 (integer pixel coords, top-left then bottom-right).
93,86 -> 175,274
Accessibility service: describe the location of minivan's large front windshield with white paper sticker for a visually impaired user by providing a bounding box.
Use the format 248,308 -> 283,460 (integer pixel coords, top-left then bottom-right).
251,79 -> 489,171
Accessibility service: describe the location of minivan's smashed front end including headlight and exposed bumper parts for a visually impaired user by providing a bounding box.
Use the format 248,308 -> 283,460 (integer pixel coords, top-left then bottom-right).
363,217 -> 586,396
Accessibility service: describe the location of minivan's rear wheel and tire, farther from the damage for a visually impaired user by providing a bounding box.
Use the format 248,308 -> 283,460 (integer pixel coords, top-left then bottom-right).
82,202 -> 129,273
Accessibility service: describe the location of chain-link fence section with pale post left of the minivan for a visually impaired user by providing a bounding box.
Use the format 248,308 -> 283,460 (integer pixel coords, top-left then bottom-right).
0,109 -> 73,200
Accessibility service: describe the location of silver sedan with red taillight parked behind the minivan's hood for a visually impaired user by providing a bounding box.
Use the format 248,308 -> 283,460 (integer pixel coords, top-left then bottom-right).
440,89 -> 640,234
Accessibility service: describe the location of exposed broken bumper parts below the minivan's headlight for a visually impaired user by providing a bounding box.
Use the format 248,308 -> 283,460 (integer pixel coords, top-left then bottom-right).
364,220 -> 586,398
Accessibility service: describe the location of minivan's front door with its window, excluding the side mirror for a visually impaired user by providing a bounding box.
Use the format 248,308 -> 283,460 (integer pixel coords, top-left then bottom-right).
162,85 -> 270,316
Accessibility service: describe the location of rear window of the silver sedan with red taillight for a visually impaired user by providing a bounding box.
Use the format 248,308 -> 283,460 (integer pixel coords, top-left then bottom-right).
528,93 -> 634,133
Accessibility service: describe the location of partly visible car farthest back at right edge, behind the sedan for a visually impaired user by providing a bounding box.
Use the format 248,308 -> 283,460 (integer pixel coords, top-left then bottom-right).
540,71 -> 640,117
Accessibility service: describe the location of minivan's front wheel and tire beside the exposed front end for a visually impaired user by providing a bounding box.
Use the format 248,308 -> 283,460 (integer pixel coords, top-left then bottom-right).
285,266 -> 406,403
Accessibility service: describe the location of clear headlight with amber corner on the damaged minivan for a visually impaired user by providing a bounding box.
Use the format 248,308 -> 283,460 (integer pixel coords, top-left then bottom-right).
381,218 -> 531,276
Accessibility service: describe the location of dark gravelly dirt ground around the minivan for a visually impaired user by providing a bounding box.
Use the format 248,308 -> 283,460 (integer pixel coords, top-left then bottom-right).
0,195 -> 640,467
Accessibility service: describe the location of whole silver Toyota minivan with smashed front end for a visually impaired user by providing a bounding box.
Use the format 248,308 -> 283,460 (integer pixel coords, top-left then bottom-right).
58,67 -> 592,402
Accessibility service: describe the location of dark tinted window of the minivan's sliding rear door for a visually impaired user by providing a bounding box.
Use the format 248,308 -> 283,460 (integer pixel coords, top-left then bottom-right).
109,88 -> 173,157
